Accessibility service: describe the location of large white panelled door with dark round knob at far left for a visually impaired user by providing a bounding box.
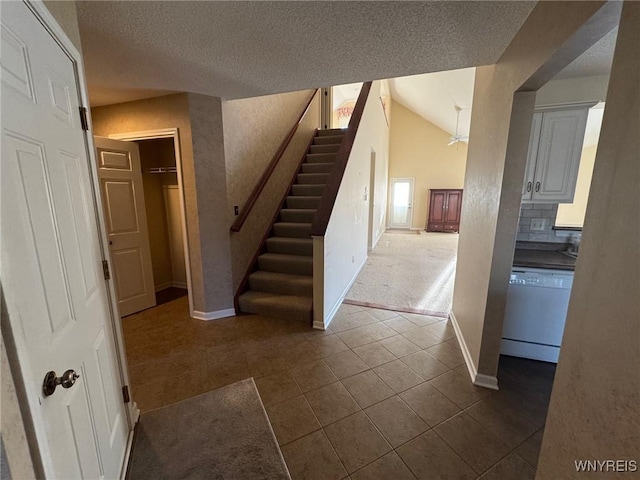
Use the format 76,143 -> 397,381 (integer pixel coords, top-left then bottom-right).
0,2 -> 130,479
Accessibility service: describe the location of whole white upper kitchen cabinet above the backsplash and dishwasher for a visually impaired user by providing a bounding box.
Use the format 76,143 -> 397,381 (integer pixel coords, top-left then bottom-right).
522,104 -> 592,203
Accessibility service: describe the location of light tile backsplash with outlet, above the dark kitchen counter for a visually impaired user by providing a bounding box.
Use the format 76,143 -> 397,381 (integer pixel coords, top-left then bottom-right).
516,203 -> 582,243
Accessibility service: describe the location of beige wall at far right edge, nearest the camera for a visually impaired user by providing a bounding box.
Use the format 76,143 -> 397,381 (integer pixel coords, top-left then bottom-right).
536,2 -> 640,474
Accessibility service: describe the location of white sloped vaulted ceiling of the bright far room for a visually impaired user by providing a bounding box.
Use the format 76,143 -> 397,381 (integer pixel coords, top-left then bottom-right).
390,68 -> 476,137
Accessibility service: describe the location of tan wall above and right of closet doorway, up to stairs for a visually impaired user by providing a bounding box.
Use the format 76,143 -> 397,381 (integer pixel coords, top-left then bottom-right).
91,93 -> 233,312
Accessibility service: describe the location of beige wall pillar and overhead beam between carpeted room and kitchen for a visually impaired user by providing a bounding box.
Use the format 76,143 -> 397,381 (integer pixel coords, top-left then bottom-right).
453,2 -> 605,384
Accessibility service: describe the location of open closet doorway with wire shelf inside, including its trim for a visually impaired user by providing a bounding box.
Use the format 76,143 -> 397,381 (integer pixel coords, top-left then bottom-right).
109,128 -> 193,315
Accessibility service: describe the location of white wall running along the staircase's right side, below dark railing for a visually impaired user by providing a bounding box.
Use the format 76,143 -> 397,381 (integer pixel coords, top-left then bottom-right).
314,81 -> 389,328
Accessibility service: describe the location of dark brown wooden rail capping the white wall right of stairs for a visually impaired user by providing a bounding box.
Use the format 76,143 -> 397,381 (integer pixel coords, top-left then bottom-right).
311,82 -> 372,237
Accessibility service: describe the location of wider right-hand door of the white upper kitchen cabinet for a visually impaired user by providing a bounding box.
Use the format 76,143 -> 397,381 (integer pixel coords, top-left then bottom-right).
525,109 -> 588,203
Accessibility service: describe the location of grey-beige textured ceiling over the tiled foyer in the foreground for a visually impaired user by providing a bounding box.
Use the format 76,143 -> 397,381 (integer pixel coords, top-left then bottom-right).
78,1 -> 535,105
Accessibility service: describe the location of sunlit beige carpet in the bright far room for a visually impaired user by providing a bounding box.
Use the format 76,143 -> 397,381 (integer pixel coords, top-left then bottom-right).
345,232 -> 458,317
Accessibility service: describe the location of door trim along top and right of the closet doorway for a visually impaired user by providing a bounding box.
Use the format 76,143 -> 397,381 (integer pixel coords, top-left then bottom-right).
108,127 -> 195,318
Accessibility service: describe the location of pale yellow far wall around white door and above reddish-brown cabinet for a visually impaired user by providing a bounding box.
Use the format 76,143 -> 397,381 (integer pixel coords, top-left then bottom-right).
389,102 -> 467,229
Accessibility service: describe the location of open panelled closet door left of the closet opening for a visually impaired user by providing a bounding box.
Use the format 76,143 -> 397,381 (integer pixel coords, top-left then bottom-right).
95,137 -> 156,317
